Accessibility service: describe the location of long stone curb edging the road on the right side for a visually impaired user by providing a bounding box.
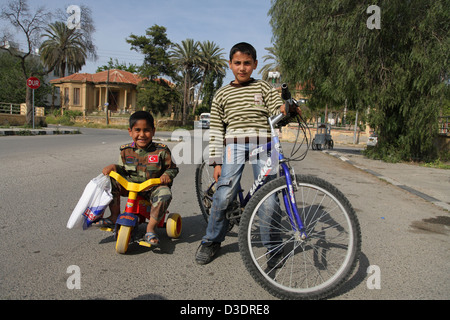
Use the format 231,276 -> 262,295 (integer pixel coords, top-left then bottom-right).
322,150 -> 450,211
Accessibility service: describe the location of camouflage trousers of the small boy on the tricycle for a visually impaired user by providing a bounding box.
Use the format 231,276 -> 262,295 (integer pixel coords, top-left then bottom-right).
110,179 -> 172,222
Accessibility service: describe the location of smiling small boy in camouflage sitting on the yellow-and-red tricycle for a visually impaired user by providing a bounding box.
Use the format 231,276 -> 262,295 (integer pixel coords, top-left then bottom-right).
96,111 -> 178,246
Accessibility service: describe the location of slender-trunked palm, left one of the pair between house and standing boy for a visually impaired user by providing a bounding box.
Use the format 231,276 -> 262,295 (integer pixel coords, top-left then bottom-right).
171,39 -> 199,125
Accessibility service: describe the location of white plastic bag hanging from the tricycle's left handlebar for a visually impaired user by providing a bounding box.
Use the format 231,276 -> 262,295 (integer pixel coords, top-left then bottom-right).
67,174 -> 112,230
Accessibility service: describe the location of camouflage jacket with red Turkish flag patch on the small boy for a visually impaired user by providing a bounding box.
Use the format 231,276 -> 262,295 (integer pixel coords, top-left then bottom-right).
117,142 -> 178,183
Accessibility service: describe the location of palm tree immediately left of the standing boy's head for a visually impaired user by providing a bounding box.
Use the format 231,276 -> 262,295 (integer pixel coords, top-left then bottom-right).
193,40 -> 227,114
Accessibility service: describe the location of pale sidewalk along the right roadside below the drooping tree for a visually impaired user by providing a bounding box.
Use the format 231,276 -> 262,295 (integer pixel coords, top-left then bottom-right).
322,146 -> 450,211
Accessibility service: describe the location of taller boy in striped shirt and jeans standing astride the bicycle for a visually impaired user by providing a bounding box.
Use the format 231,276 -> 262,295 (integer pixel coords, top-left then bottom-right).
195,42 -> 300,264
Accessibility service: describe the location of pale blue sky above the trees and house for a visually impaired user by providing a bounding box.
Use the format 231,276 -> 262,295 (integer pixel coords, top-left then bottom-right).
0,0 -> 272,83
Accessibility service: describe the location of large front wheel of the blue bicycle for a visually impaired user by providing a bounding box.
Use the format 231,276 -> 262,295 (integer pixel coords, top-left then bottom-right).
239,175 -> 361,299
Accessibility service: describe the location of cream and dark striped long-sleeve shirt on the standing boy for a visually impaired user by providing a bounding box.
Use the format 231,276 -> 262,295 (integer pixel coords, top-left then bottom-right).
209,79 -> 283,165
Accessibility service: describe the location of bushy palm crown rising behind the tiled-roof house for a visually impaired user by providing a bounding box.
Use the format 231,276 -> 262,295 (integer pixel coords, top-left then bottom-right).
39,21 -> 87,77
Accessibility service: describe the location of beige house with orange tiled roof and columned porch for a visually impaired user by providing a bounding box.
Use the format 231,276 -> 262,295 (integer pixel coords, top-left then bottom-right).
50,69 -> 143,115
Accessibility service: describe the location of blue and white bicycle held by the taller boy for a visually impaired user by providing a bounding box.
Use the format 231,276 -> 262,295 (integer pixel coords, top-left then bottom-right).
195,85 -> 361,299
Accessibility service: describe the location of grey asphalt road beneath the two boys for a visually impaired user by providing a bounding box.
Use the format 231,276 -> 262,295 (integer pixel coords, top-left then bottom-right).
0,129 -> 450,302
